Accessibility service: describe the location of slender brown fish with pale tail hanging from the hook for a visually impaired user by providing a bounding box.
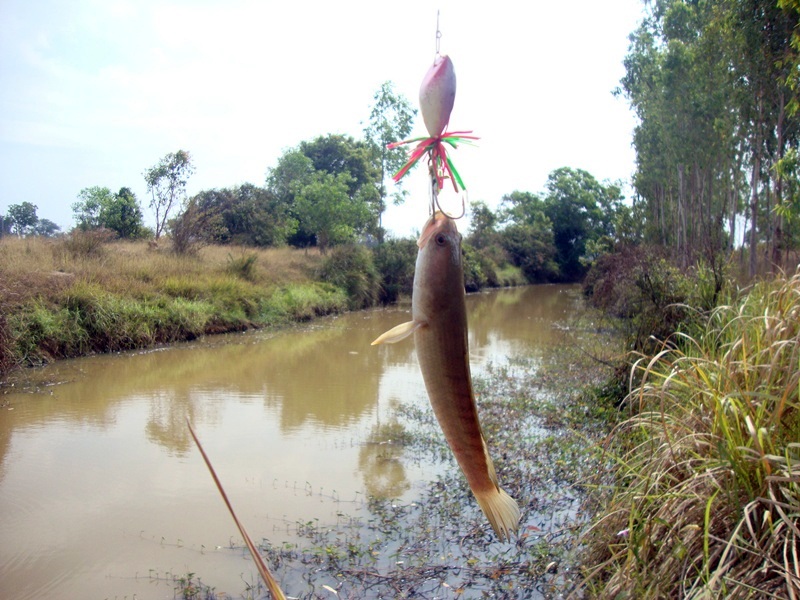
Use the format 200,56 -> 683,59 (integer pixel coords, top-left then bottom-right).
372,211 -> 520,540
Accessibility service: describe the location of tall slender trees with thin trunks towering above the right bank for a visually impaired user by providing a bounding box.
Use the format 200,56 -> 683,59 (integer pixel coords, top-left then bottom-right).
619,0 -> 800,276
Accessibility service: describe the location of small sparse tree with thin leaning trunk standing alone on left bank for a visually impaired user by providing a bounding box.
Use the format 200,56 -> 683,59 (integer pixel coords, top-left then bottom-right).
143,150 -> 194,239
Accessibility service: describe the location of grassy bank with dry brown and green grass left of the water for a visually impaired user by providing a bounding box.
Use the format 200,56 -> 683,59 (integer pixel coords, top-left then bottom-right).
0,237 -> 348,375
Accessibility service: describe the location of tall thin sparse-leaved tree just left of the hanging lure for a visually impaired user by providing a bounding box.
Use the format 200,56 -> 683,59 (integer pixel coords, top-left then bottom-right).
364,81 -> 417,242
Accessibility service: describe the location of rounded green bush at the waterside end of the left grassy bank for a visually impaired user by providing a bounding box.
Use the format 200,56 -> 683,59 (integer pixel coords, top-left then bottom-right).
319,245 -> 381,309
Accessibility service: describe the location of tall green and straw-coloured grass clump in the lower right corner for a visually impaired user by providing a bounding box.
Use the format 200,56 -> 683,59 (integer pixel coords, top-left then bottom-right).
584,276 -> 800,598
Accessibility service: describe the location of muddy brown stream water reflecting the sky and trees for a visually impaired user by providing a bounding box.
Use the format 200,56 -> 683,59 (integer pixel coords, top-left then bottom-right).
0,285 -> 579,599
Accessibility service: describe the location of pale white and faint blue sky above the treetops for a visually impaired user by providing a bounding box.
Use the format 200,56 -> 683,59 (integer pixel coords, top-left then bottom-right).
0,0 -> 643,235
